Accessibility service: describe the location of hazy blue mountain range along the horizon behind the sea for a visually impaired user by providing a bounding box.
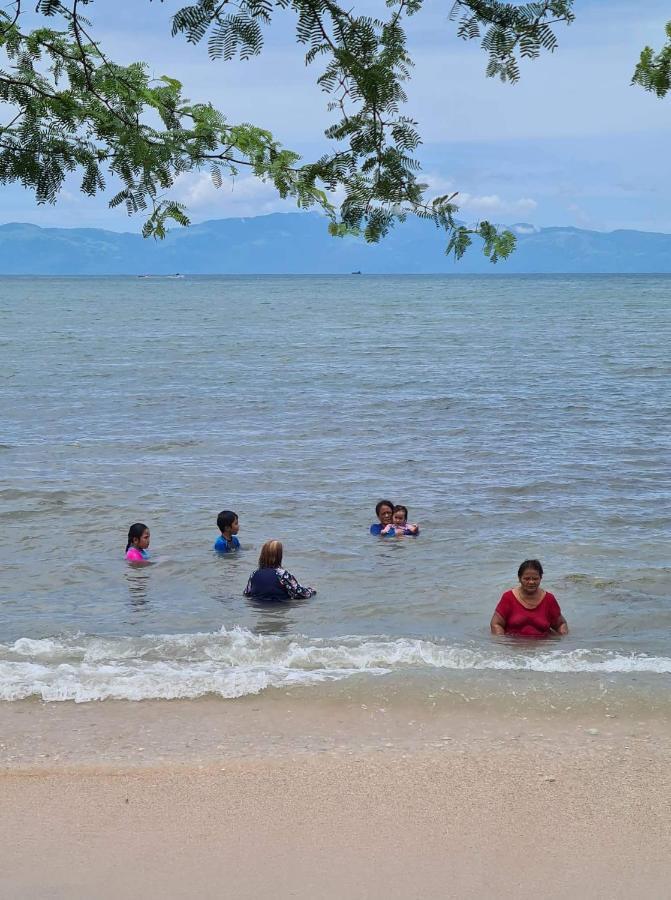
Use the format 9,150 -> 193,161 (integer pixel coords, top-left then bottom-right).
0,213 -> 671,275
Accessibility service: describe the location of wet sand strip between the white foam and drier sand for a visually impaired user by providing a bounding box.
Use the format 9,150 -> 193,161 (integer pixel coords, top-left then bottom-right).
0,673 -> 671,773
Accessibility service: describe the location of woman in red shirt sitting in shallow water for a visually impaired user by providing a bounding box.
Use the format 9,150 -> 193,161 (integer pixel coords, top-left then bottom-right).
489,559 -> 568,637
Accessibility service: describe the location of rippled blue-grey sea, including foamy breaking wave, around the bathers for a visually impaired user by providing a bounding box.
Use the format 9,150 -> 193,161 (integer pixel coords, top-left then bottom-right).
0,276 -> 671,701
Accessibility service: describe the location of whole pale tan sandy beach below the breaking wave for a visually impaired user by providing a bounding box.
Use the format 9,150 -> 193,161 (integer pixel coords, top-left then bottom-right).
0,696 -> 671,900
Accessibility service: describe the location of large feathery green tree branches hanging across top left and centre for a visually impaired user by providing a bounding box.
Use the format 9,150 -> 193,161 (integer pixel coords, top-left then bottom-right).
0,0 -> 573,255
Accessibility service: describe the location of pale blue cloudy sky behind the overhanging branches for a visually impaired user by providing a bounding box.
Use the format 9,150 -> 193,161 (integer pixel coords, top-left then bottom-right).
0,0 -> 671,232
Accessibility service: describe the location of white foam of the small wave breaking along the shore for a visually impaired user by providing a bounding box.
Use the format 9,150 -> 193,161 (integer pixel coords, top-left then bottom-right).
0,628 -> 671,702
